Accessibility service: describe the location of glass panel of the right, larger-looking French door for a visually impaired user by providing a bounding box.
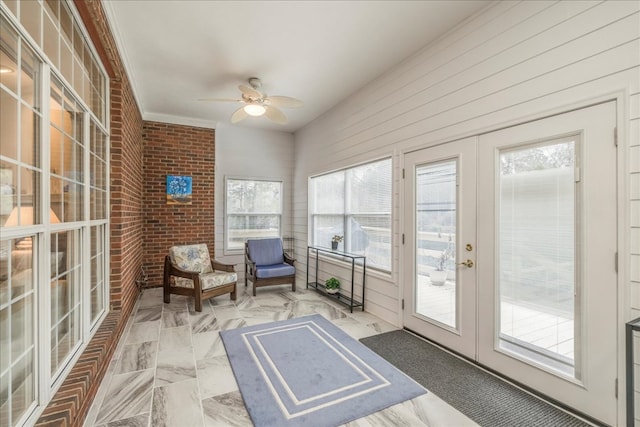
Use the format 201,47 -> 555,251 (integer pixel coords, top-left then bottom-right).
497,139 -> 577,376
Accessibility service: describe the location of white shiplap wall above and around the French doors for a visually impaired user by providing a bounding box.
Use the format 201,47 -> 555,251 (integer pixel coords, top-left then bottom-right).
293,1 -> 640,326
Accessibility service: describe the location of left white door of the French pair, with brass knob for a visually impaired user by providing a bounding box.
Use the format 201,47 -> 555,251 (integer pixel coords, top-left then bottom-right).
404,138 -> 476,358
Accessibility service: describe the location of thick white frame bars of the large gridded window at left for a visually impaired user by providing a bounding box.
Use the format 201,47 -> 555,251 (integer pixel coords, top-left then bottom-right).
0,0 -> 110,425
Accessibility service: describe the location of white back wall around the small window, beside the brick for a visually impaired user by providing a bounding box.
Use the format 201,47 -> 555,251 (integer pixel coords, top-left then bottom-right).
215,123 -> 294,272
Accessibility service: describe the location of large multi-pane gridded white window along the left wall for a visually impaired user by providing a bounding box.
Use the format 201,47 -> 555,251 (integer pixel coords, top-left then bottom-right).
0,1 -> 109,426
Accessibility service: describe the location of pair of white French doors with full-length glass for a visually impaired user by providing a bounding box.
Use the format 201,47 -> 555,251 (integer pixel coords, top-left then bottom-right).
404,102 -> 617,425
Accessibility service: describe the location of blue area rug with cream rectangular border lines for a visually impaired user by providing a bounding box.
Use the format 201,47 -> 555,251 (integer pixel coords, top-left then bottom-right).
220,314 -> 427,427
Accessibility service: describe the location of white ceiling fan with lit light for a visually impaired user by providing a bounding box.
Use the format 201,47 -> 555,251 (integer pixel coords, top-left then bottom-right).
200,77 -> 302,124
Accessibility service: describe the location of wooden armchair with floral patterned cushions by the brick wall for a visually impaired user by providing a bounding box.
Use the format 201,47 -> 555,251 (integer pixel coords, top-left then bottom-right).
164,243 -> 238,311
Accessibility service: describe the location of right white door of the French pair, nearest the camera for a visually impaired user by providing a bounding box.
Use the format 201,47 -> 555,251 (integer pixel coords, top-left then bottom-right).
478,102 -> 617,425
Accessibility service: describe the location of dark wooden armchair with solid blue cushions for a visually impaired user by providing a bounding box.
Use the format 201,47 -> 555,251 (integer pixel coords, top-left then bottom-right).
244,238 -> 296,296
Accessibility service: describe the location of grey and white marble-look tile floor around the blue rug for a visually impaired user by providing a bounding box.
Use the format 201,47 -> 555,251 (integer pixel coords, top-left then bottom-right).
84,285 -> 476,427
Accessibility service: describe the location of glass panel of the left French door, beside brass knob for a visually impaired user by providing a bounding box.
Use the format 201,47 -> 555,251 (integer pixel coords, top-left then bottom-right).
415,160 -> 457,328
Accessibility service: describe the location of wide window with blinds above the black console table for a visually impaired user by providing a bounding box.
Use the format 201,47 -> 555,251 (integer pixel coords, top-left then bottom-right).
309,159 -> 392,271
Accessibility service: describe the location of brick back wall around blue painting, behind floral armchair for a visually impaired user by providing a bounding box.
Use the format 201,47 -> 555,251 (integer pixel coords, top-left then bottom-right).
143,122 -> 215,286
